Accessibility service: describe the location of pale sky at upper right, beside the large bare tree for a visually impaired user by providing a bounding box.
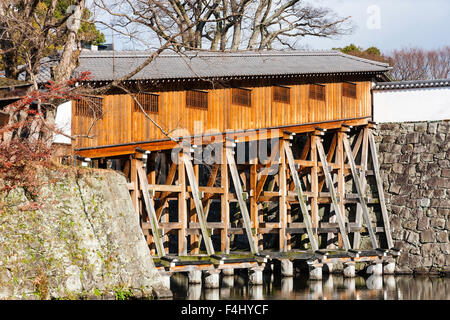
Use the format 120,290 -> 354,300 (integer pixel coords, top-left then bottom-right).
304,0 -> 450,52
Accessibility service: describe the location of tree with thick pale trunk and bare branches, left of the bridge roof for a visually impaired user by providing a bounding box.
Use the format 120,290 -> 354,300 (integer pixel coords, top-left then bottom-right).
0,0 -> 86,148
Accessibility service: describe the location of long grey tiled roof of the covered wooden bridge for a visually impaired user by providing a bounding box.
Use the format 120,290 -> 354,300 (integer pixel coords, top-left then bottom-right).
70,51 -> 390,81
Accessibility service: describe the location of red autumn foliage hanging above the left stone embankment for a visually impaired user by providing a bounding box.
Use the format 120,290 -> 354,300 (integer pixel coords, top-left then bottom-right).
0,73 -> 89,202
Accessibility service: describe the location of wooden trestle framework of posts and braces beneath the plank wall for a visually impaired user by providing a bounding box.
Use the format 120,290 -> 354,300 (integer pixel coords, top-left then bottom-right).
113,123 -> 393,257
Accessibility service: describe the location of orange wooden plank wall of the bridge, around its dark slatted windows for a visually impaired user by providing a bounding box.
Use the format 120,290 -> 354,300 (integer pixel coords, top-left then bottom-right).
72,81 -> 371,148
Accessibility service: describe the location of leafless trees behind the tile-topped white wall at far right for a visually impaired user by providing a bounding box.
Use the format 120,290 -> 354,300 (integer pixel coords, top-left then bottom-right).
389,46 -> 450,80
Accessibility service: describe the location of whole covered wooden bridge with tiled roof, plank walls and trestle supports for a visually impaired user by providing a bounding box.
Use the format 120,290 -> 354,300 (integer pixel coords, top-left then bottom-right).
68,51 -> 398,283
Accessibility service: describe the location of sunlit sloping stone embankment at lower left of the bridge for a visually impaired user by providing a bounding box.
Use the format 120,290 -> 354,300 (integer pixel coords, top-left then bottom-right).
0,167 -> 170,300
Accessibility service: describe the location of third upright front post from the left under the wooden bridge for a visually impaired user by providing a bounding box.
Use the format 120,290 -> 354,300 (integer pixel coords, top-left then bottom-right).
220,146 -> 230,254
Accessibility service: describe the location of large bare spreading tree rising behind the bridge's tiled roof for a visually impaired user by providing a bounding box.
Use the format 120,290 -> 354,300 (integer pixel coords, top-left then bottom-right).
94,0 -> 352,51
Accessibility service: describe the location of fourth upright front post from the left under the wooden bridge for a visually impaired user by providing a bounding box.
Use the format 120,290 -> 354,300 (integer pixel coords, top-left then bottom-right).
278,139 -> 289,252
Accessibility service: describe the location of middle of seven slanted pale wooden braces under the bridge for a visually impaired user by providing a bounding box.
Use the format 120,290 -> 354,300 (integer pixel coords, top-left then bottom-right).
284,139 -> 319,251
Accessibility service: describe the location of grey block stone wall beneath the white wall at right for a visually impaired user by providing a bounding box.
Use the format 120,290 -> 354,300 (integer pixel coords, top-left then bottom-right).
376,121 -> 450,273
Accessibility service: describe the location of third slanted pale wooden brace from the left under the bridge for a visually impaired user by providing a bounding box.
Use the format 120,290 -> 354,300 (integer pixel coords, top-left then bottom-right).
226,142 -> 258,254
